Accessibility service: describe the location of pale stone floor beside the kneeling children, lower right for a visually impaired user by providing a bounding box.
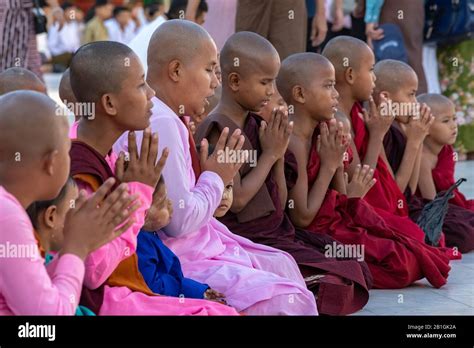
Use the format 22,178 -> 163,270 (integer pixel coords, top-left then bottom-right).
44,74 -> 474,315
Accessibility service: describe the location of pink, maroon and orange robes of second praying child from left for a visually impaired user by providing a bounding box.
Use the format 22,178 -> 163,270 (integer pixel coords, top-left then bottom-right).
70,123 -> 238,315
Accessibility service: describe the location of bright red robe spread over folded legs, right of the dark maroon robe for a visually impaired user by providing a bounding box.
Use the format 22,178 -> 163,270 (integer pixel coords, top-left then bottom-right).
286,128 -> 450,289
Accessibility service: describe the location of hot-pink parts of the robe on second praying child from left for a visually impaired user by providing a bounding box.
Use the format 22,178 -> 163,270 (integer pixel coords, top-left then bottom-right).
69,122 -> 238,315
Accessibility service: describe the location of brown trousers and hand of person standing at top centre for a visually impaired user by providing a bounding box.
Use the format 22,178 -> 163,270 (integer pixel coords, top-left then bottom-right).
235,0 -> 327,60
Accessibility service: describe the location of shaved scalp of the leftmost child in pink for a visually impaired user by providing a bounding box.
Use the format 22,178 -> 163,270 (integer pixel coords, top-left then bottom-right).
0,91 -> 67,164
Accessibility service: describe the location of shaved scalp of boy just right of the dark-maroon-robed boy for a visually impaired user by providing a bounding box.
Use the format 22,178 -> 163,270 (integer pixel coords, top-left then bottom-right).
276,52 -> 333,103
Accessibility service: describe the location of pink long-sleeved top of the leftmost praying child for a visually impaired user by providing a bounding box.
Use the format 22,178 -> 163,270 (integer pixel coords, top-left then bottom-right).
0,206 -> 84,315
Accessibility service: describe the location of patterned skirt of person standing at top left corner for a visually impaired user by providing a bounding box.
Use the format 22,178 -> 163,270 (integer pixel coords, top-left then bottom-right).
0,0 -> 42,78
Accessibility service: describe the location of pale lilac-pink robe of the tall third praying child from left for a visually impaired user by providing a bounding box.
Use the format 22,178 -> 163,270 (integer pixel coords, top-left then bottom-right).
114,98 -> 317,315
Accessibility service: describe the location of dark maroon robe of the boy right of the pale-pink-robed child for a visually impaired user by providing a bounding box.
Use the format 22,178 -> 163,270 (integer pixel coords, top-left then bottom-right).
195,114 -> 372,315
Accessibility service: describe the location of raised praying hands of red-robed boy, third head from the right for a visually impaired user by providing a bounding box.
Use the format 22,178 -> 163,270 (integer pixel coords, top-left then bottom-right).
359,93 -> 395,139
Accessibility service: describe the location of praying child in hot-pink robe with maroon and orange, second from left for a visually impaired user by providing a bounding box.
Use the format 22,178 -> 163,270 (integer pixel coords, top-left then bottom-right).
70,41 -> 237,315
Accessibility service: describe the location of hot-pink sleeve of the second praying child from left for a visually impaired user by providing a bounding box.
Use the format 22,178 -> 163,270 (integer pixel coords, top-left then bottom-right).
76,180 -> 153,289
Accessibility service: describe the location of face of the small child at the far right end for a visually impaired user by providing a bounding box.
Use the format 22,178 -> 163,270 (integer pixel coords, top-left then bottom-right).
429,103 -> 458,145
